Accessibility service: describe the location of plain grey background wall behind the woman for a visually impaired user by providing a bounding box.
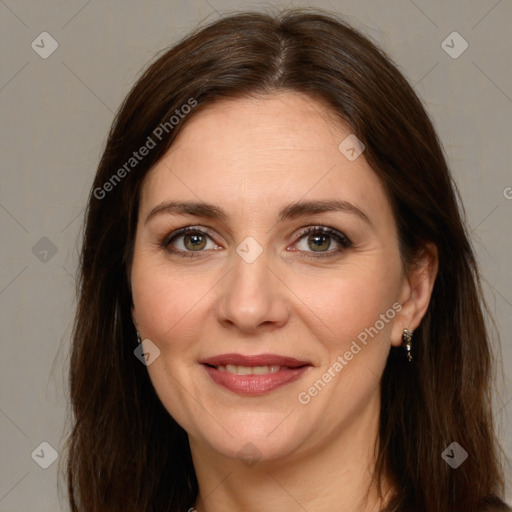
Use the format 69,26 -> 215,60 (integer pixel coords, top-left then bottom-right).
0,0 -> 512,512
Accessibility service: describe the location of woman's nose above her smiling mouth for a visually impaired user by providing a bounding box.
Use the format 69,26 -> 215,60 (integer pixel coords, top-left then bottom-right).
216,246 -> 290,333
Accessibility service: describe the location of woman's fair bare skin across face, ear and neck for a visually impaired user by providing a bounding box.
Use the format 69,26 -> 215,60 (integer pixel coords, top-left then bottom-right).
131,92 -> 437,512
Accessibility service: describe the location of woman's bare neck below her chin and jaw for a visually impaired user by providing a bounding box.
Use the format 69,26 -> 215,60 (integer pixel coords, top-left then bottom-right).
190,390 -> 392,512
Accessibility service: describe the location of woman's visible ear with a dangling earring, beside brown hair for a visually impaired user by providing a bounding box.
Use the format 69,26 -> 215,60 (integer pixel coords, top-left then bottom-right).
391,242 -> 439,347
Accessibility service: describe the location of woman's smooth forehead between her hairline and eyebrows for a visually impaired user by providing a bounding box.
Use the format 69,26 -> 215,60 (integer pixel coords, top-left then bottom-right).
142,92 -> 390,226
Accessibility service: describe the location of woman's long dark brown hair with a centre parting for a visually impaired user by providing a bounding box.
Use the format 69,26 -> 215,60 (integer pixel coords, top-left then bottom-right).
62,10 -> 510,512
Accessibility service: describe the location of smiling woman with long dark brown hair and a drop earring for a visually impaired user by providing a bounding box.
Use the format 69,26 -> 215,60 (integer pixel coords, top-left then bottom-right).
63,8 -> 509,512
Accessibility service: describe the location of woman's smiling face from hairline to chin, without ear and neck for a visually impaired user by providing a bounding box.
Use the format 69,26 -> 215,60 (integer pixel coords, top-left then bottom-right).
131,93 -> 412,461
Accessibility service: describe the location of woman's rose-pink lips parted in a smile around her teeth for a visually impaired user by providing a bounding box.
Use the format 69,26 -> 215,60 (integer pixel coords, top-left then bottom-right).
200,354 -> 312,396
